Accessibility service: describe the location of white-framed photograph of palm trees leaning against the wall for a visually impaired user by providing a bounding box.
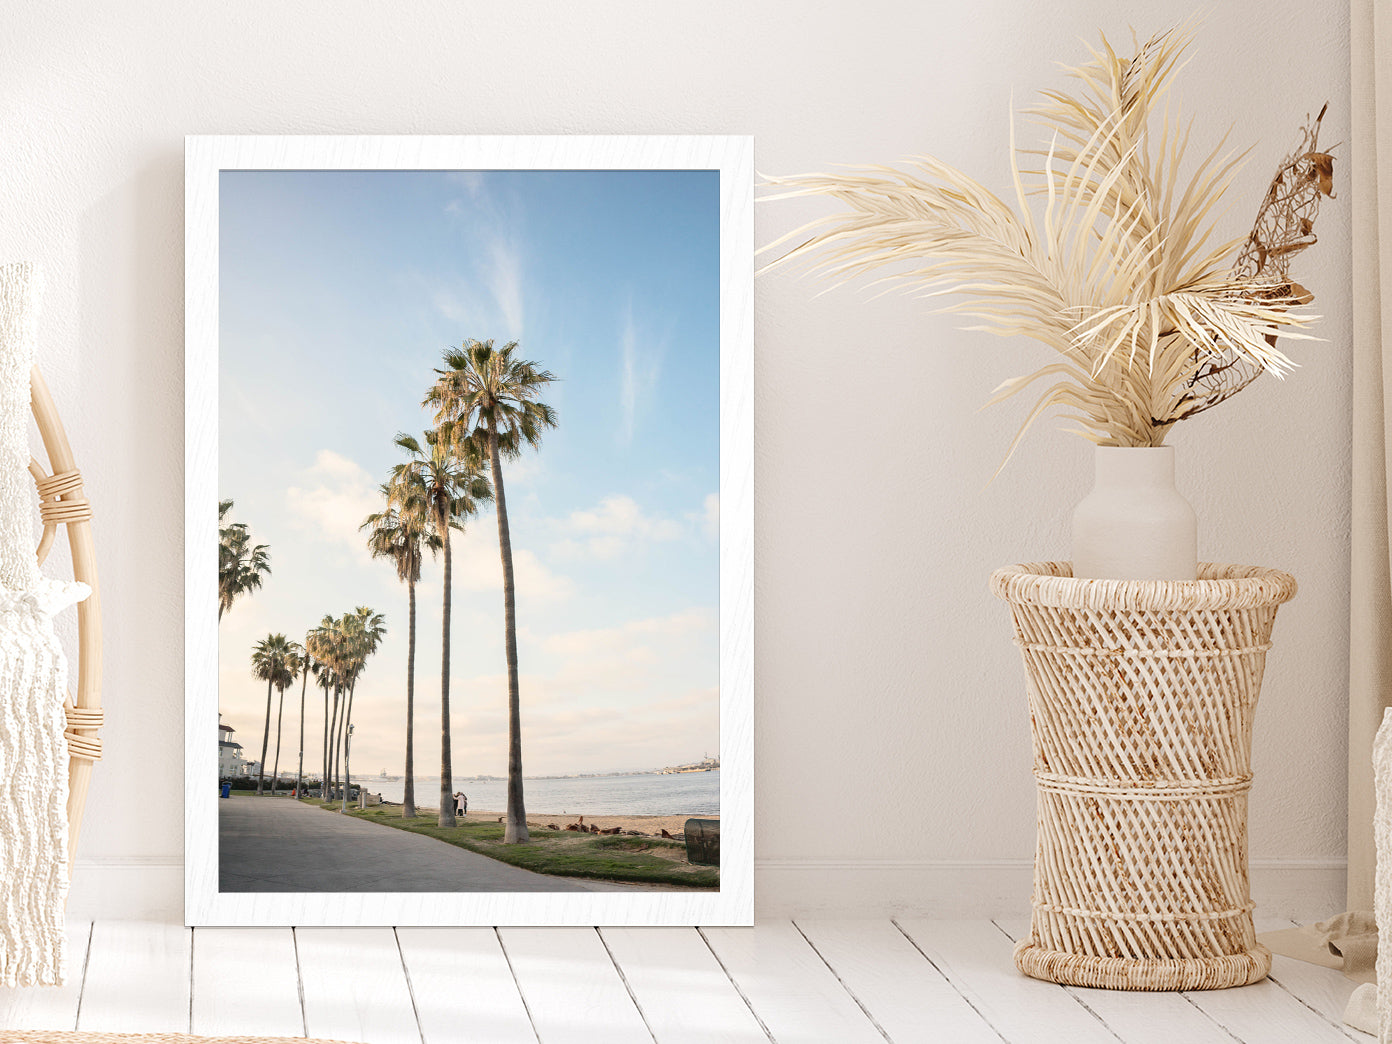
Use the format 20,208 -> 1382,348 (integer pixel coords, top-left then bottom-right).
185,136 -> 753,926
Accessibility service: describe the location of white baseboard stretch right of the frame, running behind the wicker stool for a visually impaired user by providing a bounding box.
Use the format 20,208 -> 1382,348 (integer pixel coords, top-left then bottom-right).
754,859 -> 1346,920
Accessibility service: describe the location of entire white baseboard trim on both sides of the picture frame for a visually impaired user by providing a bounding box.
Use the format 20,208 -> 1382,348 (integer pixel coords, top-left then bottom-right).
68,859 -> 1346,923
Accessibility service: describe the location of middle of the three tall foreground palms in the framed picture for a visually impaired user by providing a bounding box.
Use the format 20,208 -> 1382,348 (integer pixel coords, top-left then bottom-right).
390,427 -> 493,827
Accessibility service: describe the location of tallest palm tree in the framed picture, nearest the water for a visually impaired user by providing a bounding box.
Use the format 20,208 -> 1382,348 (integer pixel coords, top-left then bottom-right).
422,340 -> 555,845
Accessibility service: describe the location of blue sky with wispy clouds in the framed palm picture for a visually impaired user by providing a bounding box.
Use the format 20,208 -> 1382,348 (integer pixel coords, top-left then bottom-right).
219,171 -> 720,775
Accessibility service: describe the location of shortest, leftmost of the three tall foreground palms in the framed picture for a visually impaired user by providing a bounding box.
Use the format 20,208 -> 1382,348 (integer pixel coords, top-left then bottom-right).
359,492 -> 440,820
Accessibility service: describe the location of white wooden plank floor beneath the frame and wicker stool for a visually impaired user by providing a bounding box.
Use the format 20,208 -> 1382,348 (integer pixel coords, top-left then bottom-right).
0,919 -> 1373,1044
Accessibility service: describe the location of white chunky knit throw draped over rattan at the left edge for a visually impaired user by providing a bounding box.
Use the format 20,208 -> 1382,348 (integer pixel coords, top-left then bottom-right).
0,263 -> 89,986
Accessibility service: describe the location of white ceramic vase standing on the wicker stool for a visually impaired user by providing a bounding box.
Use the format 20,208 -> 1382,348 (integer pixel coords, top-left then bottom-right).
1073,445 -> 1199,580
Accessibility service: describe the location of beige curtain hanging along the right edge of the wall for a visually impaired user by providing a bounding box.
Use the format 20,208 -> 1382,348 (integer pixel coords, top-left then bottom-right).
1346,0 -> 1392,910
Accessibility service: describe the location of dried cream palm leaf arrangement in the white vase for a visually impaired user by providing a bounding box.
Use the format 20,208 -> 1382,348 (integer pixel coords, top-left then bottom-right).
763,28 -> 1334,451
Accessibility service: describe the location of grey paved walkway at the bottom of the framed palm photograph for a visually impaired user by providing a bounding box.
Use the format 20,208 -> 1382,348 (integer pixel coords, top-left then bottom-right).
217,795 -> 633,892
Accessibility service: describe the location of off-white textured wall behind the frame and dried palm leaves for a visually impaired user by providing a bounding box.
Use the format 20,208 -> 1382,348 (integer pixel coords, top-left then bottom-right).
0,0 -> 1350,916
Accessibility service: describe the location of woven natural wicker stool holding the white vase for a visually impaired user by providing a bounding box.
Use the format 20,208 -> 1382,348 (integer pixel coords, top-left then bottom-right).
991,562 -> 1296,990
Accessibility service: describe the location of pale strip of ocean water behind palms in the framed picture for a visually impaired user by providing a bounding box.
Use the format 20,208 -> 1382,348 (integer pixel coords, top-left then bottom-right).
354,768 -> 720,817
